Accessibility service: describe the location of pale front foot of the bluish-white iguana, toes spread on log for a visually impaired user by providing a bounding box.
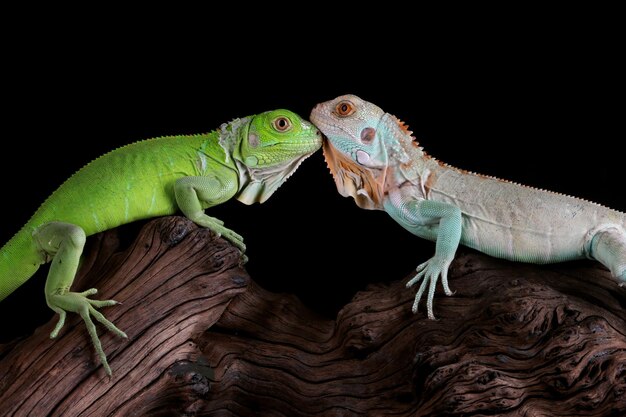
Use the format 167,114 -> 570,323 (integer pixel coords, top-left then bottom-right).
406,256 -> 453,320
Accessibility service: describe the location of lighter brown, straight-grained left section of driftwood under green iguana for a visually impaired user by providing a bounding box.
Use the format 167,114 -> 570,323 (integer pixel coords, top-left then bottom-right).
0,217 -> 248,416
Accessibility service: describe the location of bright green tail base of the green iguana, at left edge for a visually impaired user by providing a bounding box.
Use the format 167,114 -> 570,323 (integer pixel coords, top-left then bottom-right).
0,228 -> 45,301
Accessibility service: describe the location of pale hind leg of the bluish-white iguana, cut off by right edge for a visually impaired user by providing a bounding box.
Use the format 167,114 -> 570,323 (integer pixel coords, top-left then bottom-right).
589,226 -> 626,287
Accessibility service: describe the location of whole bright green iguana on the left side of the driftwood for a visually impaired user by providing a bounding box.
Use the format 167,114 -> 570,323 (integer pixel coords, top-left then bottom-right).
0,110 -> 322,375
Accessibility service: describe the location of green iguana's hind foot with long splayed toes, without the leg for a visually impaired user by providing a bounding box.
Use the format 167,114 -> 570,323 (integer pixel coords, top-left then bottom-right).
46,288 -> 128,376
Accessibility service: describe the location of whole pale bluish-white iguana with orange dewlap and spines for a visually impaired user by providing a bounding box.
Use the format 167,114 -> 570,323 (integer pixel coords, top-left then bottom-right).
310,95 -> 626,319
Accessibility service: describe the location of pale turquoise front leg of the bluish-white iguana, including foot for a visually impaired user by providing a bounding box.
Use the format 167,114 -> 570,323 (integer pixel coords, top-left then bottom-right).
384,188 -> 462,319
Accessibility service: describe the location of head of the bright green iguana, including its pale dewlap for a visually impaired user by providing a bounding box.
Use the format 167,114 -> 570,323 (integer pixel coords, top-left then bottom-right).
233,109 -> 322,204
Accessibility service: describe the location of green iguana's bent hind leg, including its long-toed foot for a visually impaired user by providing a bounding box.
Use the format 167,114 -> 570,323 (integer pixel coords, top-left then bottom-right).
33,222 -> 127,375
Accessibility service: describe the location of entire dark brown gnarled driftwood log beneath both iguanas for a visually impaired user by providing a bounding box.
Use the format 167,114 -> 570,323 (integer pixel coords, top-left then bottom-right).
0,217 -> 626,416
